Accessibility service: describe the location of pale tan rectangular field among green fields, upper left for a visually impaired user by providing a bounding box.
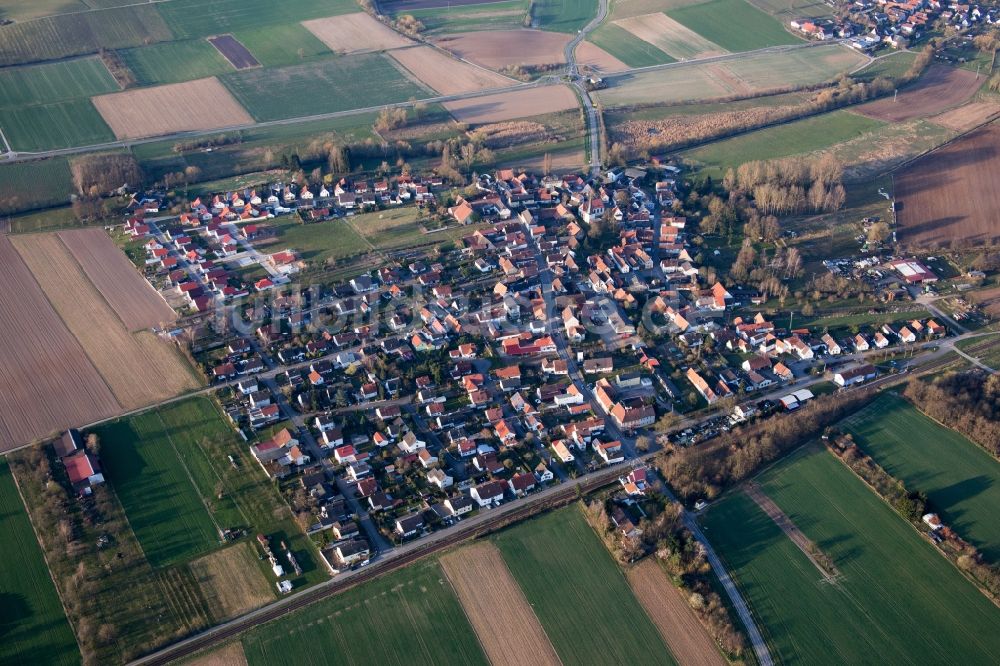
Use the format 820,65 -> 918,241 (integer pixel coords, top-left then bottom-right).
93,77 -> 253,139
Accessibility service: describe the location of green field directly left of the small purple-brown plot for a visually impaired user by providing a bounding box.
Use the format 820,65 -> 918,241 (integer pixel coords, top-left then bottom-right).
119,39 -> 234,86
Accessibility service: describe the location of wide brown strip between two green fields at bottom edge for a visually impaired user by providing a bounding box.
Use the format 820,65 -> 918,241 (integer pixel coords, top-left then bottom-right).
441,542 -> 561,666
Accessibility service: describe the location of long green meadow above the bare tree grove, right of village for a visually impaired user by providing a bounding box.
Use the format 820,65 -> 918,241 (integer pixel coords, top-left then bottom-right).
683,111 -> 885,172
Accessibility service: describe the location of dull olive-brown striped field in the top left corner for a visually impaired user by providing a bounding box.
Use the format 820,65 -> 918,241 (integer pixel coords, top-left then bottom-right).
0,3 -> 172,65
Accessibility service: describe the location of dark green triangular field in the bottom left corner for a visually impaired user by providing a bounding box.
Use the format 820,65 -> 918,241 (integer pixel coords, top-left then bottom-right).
0,459 -> 80,665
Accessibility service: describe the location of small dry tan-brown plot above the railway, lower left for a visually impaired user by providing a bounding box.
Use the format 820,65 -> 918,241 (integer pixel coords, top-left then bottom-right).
190,542 -> 274,620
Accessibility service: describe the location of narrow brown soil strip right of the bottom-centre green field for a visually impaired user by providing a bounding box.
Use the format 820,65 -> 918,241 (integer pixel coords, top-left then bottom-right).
625,557 -> 726,666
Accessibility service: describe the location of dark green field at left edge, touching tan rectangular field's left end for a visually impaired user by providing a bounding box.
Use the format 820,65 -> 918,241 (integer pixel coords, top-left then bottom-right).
0,99 -> 115,152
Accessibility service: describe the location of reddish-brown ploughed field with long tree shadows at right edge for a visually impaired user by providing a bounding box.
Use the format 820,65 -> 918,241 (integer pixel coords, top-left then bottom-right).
894,122 -> 1000,248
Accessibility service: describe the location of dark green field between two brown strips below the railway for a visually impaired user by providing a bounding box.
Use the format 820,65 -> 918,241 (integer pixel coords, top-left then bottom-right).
496,506 -> 675,664
